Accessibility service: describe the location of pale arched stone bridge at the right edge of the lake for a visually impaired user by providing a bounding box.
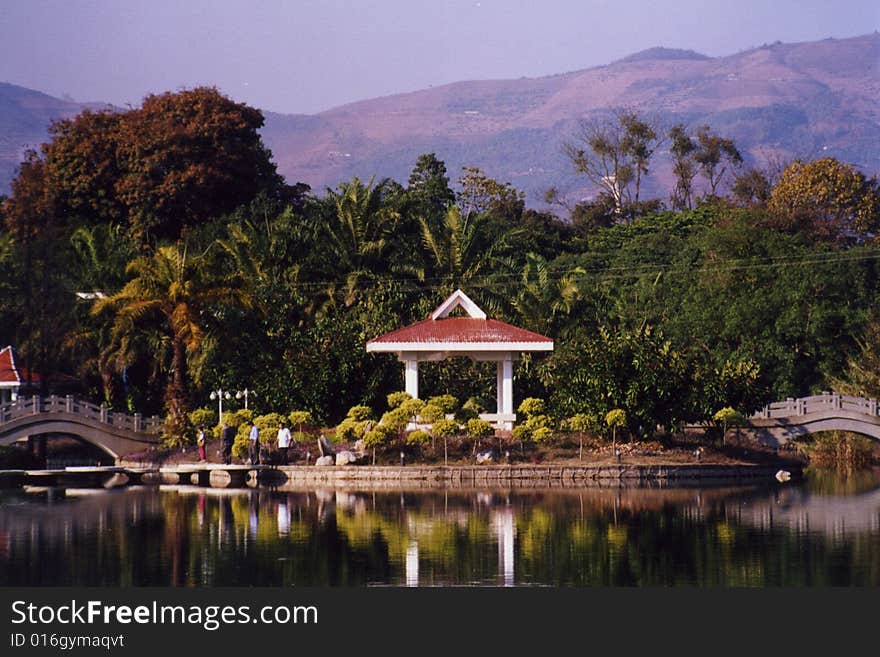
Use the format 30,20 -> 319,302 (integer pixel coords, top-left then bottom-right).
742,392 -> 880,447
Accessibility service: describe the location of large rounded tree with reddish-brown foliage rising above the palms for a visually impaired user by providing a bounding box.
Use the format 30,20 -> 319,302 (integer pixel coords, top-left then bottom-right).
19,87 -> 281,243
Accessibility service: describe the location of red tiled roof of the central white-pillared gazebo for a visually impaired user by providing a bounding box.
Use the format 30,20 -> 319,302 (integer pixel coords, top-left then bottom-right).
367,317 -> 553,346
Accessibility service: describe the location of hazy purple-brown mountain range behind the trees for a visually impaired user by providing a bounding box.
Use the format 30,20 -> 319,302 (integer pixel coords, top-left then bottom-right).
0,33 -> 880,202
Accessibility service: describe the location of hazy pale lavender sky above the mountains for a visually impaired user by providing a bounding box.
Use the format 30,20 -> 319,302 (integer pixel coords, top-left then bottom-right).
0,0 -> 880,113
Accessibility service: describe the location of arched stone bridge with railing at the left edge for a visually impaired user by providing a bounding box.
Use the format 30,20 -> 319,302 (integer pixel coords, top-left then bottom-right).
0,395 -> 162,460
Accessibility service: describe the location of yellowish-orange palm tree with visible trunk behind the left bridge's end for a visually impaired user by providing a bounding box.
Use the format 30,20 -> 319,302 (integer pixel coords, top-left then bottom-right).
92,244 -> 254,440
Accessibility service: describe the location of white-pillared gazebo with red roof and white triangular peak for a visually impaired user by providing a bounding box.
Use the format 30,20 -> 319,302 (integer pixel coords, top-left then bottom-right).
367,290 -> 553,430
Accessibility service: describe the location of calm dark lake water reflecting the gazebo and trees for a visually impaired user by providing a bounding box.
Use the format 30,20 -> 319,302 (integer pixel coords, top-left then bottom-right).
0,468 -> 880,587
